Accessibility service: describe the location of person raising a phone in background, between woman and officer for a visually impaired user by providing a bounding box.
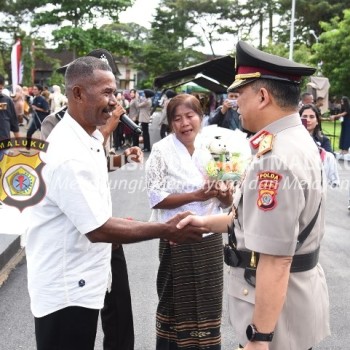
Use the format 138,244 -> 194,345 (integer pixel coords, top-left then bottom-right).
209,92 -> 241,130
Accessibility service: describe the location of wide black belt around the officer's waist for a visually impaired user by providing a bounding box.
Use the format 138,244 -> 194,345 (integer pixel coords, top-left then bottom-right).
236,247 -> 320,272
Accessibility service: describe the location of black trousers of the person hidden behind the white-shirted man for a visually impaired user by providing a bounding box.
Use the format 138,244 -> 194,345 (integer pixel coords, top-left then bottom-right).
101,246 -> 134,350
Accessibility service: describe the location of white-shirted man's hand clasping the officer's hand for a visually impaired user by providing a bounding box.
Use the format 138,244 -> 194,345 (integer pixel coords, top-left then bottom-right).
164,211 -> 207,244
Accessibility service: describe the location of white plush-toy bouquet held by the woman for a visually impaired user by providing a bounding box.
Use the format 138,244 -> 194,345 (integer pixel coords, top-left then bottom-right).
197,125 -> 251,182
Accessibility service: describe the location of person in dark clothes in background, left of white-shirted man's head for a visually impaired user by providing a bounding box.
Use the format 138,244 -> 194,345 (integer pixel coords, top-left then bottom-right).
27,84 -> 50,140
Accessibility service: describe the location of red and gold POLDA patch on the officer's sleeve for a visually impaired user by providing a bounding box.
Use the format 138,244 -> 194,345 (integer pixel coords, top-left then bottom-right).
257,171 -> 282,211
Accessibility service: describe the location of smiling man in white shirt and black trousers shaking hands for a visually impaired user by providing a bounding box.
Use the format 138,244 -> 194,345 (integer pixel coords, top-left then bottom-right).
26,57 -> 203,350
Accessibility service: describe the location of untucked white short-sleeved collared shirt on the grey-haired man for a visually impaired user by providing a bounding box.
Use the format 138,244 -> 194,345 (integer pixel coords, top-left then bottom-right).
26,113 -> 112,317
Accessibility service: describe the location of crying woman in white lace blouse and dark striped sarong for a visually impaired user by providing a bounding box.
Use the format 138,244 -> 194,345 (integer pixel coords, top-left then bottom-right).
146,94 -> 232,350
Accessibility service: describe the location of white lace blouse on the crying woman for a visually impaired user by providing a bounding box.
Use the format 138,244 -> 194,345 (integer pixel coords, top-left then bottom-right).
146,134 -> 221,222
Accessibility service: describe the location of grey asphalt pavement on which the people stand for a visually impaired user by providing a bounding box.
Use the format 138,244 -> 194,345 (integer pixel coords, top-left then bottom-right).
0,157 -> 350,350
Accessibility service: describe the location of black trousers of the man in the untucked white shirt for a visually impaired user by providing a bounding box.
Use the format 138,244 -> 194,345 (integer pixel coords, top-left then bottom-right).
35,306 -> 99,350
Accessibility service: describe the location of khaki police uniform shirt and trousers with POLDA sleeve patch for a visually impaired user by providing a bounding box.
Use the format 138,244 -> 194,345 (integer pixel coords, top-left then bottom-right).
228,113 -> 330,350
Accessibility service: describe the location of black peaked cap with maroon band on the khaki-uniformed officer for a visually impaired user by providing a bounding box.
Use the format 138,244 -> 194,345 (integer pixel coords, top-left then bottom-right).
227,41 -> 316,91
